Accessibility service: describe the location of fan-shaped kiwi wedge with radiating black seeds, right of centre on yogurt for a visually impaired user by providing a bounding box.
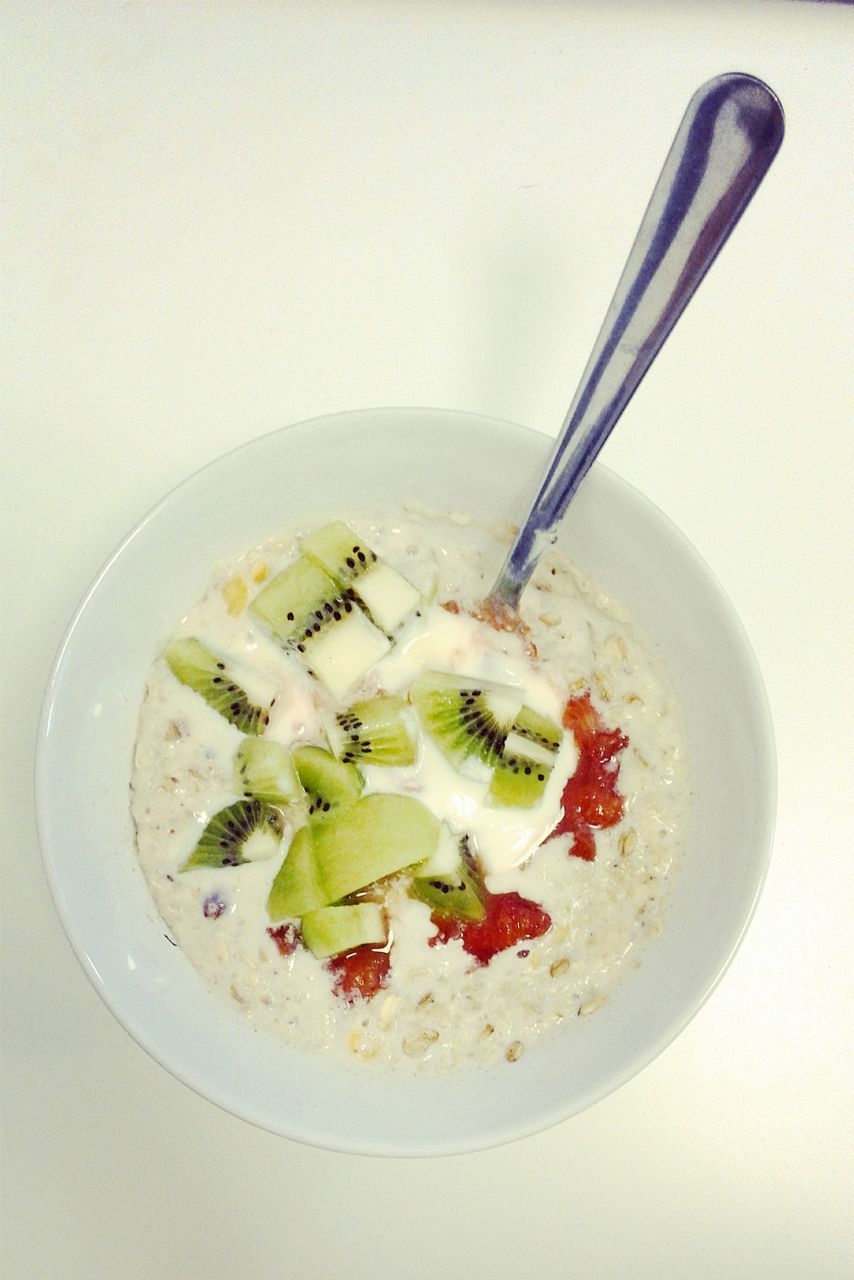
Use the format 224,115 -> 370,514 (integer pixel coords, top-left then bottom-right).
410,671 -> 522,768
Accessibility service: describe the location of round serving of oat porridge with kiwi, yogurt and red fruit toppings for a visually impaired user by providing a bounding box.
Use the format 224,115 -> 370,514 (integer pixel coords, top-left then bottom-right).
131,508 -> 689,1071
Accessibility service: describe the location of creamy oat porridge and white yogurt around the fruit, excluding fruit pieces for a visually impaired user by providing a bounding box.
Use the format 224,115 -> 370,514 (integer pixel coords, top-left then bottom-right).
132,509 -> 689,1070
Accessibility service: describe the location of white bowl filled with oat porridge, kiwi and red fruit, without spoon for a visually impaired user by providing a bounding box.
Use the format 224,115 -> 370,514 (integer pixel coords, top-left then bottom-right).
37,410 -> 775,1155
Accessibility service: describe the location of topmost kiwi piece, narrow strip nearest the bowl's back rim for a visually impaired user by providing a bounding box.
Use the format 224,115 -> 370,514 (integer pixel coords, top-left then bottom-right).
300,520 -> 421,635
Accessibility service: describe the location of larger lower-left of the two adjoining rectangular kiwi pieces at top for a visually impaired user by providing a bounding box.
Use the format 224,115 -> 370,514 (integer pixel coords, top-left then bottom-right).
250,556 -> 389,698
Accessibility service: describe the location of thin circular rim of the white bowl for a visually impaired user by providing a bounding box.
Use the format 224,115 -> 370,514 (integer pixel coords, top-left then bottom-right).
33,406 -> 778,1157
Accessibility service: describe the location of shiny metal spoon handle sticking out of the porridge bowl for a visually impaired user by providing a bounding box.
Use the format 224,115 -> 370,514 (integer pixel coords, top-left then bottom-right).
489,73 -> 784,611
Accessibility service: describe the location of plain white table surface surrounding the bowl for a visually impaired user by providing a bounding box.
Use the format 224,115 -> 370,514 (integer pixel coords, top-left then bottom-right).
0,0 -> 854,1280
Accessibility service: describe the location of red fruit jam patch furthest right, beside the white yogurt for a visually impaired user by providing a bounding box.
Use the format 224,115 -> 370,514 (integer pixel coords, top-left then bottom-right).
549,694 -> 629,861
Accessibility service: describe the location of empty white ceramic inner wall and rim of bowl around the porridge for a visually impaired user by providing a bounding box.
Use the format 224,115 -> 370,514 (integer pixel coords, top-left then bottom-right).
36,408 -> 775,1156
